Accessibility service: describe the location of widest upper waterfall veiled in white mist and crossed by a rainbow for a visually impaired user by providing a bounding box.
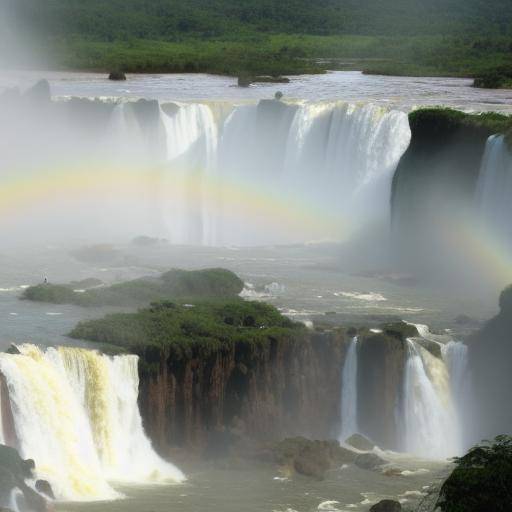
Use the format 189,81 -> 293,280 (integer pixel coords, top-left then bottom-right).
0,98 -> 411,246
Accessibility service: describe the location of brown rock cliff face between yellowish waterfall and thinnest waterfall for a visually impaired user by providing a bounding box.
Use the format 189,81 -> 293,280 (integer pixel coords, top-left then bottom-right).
139,333 -> 346,454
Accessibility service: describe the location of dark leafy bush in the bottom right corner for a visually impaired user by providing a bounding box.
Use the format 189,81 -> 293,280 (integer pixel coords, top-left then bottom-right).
438,436 -> 512,512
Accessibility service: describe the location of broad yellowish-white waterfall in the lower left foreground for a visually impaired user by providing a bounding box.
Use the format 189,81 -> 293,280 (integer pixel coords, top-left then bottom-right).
0,344 -> 184,500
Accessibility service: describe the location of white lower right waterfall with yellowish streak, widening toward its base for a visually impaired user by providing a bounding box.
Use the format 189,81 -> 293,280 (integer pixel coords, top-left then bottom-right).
402,339 -> 460,458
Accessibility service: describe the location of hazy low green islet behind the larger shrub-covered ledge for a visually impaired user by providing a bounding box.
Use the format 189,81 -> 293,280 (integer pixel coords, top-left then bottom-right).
22,268 -> 243,306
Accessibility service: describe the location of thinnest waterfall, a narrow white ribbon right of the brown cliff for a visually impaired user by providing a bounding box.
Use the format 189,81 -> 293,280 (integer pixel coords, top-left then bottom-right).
339,336 -> 358,442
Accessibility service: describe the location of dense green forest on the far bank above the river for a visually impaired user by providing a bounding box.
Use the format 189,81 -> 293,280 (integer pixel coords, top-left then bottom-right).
6,0 -> 512,76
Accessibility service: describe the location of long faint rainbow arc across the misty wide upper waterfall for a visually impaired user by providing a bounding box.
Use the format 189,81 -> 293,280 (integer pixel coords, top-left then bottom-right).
0,164 -> 351,241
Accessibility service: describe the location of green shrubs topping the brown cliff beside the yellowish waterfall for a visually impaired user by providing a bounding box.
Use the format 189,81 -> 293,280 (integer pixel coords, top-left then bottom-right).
70,299 -> 305,365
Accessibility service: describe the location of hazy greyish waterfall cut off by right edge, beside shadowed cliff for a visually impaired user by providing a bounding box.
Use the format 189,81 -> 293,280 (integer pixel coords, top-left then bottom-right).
476,135 -> 512,251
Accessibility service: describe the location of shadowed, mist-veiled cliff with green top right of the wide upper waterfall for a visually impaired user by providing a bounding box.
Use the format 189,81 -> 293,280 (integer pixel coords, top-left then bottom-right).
391,109 -> 510,274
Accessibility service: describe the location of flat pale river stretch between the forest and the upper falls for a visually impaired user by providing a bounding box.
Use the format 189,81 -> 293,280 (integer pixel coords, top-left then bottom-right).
0,71 -> 512,112
